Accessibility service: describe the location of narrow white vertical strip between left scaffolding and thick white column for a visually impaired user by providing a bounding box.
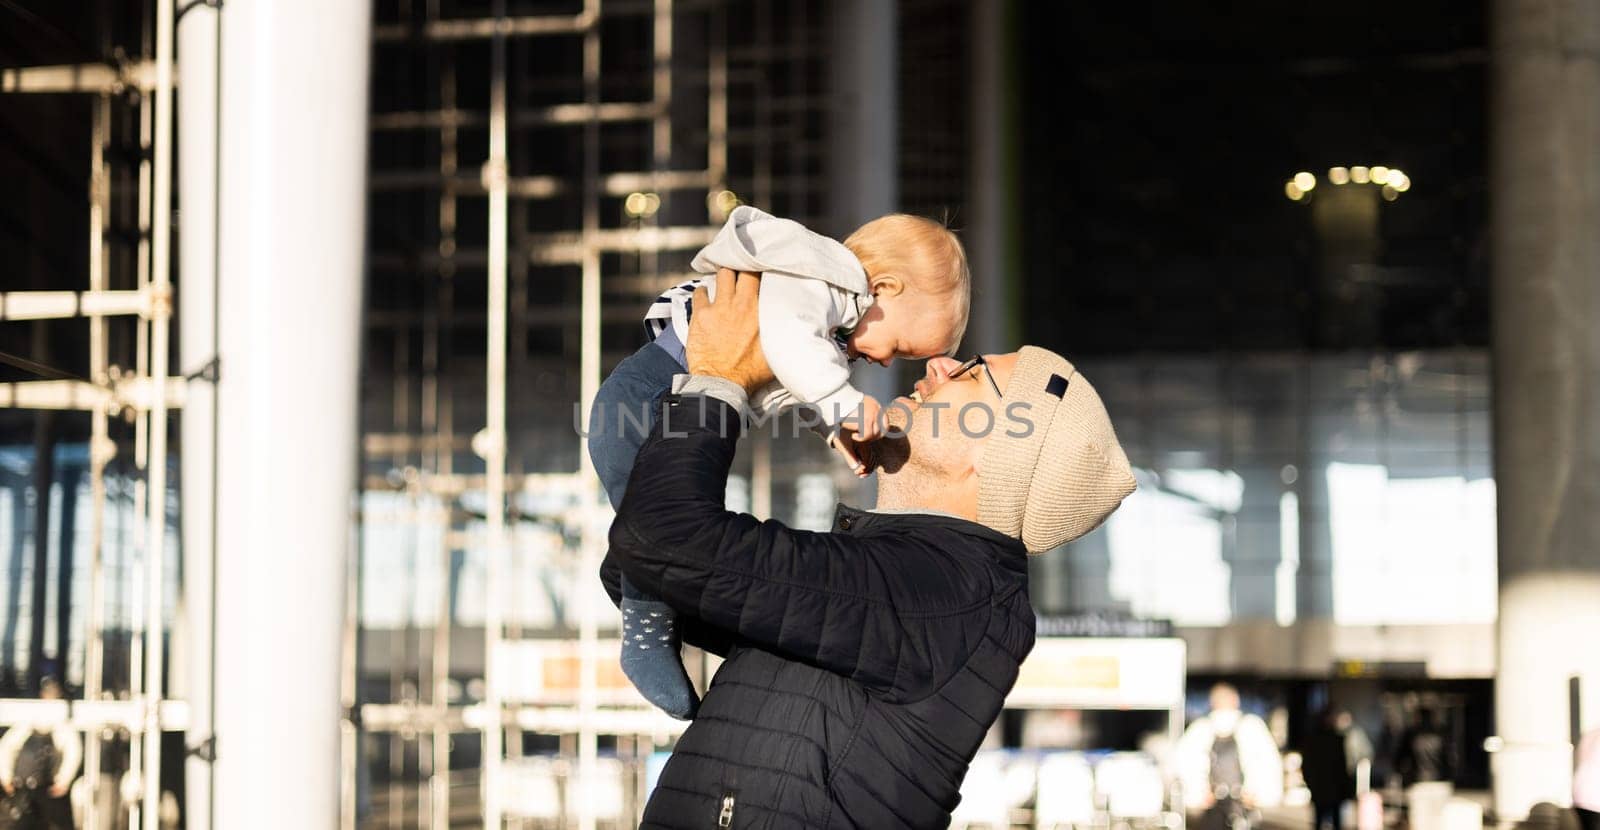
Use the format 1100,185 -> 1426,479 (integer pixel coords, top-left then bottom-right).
173,5 -> 219,830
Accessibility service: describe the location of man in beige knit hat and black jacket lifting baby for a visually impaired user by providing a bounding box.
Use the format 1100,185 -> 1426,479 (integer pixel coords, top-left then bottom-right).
602,272 -> 1134,830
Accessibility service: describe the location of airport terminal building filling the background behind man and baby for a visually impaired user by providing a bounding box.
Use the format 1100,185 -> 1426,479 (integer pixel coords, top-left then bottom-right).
0,0 -> 1600,830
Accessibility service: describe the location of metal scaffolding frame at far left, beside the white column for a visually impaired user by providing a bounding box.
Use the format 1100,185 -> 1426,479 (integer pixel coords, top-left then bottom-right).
0,0 -> 189,830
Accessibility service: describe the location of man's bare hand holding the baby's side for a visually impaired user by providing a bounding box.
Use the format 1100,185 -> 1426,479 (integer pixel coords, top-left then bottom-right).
685,269 -> 773,395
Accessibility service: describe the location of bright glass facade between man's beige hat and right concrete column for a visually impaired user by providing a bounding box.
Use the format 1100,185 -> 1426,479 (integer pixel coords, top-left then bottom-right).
1034,349 -> 1496,625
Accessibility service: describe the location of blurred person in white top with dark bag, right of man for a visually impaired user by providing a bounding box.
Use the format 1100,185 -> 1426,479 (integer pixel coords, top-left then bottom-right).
1176,683 -> 1283,827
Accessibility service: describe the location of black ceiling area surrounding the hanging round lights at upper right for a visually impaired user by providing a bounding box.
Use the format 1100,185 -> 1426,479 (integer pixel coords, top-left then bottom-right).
1018,0 -> 1488,353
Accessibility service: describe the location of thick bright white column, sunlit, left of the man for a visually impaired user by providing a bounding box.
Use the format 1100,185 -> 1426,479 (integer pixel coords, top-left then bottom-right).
213,0 -> 371,830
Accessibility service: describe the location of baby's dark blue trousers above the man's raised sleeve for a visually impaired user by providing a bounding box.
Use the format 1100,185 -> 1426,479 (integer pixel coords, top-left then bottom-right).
589,337 -> 685,509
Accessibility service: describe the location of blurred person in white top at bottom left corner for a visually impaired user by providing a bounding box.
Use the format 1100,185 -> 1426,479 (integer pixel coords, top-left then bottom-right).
0,676 -> 83,830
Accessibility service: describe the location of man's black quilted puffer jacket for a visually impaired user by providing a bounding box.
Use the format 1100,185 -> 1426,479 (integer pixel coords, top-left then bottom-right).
602,395 -> 1034,830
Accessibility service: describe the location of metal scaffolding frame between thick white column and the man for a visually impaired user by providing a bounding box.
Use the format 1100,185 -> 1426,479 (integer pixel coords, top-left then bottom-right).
358,0 -> 829,828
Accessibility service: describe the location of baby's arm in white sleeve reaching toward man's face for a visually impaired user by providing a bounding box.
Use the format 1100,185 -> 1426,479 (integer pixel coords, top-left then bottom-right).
757,272 -> 864,429
